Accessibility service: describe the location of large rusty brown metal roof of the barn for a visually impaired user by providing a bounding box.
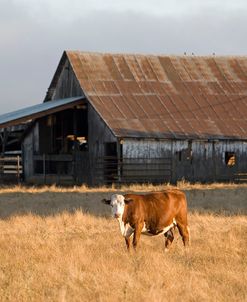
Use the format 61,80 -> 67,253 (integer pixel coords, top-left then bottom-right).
65,51 -> 247,139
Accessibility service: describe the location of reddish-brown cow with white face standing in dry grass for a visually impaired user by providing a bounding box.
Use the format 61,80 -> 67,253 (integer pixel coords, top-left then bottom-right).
102,189 -> 190,251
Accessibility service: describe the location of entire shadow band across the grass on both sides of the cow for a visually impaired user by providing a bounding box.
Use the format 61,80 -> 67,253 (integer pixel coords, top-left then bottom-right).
0,188 -> 247,219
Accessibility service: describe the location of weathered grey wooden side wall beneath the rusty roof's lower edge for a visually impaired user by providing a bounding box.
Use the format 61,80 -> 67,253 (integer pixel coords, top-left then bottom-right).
122,139 -> 247,182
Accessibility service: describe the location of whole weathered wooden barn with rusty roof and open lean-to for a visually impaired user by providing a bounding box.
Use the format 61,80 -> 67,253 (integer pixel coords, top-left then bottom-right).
0,51 -> 247,185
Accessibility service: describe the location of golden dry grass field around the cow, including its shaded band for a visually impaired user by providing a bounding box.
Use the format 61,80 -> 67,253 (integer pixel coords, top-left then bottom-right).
0,184 -> 247,302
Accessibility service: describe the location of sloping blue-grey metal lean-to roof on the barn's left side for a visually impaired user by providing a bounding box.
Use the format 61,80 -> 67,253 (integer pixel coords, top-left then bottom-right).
0,97 -> 83,128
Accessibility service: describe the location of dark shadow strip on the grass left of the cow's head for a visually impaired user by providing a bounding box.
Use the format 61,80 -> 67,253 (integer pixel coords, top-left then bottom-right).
0,192 -> 111,219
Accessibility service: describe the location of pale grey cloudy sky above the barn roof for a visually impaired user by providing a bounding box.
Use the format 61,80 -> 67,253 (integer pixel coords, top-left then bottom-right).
0,0 -> 247,115
